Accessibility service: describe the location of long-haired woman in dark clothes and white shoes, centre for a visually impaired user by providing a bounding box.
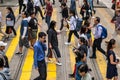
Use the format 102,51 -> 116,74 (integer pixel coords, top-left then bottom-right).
47,21 -> 62,66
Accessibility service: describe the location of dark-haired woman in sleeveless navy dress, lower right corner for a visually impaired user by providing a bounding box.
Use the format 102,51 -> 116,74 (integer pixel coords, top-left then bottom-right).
106,39 -> 119,80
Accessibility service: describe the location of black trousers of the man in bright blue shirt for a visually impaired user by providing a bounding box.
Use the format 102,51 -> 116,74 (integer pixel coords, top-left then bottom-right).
34,60 -> 47,80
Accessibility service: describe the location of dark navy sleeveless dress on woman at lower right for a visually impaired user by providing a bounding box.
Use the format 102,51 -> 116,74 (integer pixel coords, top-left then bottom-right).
106,50 -> 118,79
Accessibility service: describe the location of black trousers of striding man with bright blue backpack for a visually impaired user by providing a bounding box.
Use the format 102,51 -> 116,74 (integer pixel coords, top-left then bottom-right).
92,38 -> 106,57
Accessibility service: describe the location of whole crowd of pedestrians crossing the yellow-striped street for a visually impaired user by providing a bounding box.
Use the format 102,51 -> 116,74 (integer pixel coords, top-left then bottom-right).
0,0 -> 120,80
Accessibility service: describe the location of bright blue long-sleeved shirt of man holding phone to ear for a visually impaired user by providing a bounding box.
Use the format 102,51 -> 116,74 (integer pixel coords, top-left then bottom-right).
34,41 -> 47,68
